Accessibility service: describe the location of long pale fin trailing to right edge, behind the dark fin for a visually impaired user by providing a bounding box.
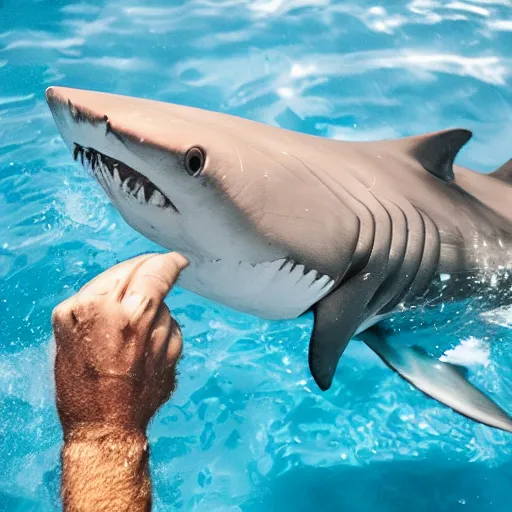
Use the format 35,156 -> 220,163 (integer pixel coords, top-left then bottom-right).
358,329 -> 512,432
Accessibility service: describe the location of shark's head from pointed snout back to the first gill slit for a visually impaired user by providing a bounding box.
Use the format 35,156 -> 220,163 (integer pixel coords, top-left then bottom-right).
46,87 -> 358,318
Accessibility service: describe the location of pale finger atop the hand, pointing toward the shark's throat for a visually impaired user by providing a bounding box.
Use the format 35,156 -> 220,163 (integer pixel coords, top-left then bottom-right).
122,252 -> 188,314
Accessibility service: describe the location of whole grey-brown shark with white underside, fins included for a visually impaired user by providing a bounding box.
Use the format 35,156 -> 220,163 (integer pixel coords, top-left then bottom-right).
46,87 -> 512,431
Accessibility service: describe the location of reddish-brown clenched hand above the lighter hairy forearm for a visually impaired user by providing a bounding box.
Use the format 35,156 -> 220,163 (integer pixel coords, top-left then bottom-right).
52,253 -> 188,437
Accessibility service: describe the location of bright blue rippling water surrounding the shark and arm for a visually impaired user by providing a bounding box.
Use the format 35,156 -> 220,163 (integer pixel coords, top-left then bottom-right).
0,0 -> 512,512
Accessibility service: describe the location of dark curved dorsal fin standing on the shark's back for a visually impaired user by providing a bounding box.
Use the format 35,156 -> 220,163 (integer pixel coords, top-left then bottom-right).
405,128 -> 472,183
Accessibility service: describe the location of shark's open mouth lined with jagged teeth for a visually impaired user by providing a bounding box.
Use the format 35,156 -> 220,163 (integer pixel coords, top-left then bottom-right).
73,142 -> 179,213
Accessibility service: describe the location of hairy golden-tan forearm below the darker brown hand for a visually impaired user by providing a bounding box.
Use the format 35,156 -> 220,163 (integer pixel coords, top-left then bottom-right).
61,427 -> 151,512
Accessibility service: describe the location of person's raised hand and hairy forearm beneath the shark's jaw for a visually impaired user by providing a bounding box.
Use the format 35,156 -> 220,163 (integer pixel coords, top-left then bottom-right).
52,253 -> 188,512
